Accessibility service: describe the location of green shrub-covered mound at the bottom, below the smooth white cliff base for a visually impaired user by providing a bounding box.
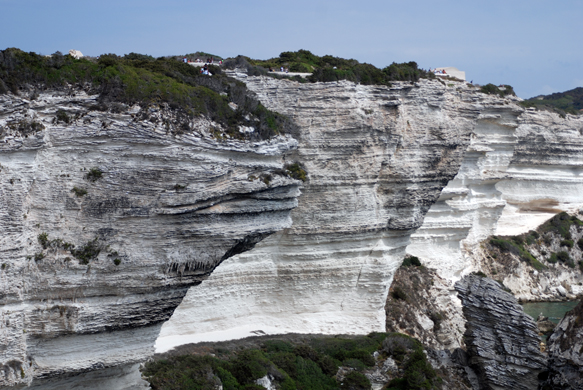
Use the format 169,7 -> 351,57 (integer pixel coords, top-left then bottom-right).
142,333 -> 441,390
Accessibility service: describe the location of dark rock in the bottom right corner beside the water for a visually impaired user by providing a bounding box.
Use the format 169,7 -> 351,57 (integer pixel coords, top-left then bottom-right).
541,301 -> 583,390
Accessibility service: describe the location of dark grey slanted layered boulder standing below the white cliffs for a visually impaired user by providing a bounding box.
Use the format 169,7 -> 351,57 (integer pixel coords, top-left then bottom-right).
455,275 -> 546,390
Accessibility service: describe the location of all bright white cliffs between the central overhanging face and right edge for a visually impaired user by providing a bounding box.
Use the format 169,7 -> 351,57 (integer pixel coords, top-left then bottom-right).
407,106 -> 583,284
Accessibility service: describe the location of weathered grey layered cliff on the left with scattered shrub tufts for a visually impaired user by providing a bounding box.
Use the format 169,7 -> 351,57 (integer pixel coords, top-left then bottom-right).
0,91 -> 300,388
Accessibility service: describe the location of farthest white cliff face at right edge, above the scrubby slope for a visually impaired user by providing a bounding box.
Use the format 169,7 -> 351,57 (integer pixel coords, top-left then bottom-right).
496,111 -> 583,235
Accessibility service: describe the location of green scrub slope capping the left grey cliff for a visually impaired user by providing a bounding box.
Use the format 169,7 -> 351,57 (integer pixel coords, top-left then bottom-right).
0,48 -> 292,139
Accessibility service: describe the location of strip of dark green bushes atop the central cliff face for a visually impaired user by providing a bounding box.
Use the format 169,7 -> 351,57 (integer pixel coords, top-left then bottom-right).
225,50 -> 435,85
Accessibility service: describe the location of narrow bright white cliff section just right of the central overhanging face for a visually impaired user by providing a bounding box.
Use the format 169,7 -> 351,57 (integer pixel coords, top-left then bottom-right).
407,99 -> 523,281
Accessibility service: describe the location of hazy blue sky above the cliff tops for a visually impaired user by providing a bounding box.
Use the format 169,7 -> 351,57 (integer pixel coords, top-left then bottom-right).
0,0 -> 583,98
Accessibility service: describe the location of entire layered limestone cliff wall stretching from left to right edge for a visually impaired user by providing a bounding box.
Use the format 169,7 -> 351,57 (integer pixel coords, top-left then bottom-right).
0,67 -> 583,388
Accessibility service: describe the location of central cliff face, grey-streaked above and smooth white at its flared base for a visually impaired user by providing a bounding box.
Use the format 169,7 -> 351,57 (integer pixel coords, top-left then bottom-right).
156,77 -> 487,351
